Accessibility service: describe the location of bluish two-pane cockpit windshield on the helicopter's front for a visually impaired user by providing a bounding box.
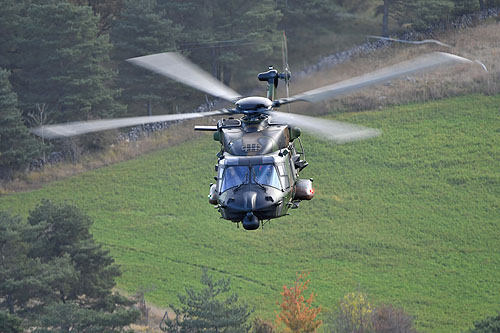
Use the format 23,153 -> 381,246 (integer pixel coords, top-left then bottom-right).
220,164 -> 282,193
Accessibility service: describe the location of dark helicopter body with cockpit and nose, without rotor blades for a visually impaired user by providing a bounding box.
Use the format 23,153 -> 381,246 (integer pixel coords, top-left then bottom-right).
205,105 -> 314,230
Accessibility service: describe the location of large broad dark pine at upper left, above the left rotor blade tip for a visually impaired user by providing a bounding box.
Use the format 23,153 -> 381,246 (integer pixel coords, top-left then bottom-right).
10,0 -> 124,122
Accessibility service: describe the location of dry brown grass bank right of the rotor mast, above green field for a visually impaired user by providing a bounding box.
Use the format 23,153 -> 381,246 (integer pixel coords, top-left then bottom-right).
291,19 -> 500,114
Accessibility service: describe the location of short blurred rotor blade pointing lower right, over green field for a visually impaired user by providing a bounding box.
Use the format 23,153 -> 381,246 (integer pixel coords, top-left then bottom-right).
269,111 -> 381,143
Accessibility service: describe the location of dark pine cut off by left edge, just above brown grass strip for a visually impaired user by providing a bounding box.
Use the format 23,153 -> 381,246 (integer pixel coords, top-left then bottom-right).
0,69 -> 40,179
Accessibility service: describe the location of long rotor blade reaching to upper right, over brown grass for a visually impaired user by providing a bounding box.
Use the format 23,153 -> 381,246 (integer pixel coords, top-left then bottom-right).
274,52 -> 473,106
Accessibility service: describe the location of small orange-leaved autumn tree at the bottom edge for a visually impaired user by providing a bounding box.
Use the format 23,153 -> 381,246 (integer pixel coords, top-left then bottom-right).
276,273 -> 323,332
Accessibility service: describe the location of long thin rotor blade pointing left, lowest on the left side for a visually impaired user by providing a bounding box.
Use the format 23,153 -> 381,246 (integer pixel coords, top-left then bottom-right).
31,110 -> 231,139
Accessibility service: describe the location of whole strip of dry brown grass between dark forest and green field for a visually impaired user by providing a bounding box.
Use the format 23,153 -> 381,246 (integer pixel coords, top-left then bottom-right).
0,18 -> 500,195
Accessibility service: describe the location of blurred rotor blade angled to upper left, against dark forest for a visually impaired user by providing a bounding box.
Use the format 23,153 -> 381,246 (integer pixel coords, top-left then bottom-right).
127,52 -> 241,103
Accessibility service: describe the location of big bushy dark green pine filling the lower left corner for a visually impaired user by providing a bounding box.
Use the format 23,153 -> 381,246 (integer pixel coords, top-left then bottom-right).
0,201 -> 139,332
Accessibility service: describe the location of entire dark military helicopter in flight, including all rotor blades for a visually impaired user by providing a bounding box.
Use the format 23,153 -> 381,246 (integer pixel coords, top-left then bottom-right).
32,47 -> 472,230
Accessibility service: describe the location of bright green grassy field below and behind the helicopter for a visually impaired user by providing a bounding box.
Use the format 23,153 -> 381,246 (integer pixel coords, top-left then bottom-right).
0,96 -> 500,332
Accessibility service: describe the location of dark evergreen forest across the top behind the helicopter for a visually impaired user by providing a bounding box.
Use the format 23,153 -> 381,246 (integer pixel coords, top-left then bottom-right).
0,0 -> 500,179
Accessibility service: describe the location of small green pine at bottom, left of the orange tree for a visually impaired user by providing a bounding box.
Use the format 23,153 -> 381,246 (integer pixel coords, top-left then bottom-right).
164,269 -> 253,332
